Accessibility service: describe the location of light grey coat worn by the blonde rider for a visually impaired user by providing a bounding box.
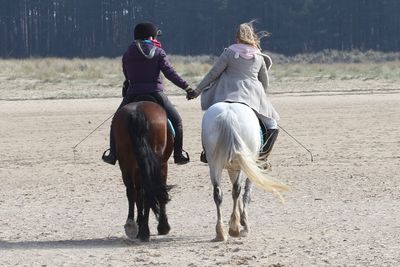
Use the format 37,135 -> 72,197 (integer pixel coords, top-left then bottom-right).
196,48 -> 279,120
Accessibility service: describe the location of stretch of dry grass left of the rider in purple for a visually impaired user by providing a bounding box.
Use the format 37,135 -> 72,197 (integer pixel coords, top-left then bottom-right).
0,58 -> 122,99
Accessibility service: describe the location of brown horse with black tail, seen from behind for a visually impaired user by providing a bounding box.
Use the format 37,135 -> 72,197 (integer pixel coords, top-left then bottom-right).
112,101 -> 173,241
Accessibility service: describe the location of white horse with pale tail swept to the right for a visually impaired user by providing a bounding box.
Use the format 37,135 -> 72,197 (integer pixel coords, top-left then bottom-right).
201,102 -> 288,241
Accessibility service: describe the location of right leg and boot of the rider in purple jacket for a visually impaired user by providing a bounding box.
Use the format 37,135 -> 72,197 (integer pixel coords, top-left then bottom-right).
158,92 -> 190,164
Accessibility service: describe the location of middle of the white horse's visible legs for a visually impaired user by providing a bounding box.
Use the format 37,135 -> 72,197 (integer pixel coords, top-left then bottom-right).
228,170 -> 241,237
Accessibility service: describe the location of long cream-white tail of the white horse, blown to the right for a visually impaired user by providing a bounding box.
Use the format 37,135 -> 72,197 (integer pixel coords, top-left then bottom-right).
213,109 -> 289,196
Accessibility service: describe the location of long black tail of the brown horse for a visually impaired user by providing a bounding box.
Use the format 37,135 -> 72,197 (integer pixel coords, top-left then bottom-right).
128,111 -> 169,218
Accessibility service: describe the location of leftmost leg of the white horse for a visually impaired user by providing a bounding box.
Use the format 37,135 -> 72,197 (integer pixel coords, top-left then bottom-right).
210,166 -> 227,241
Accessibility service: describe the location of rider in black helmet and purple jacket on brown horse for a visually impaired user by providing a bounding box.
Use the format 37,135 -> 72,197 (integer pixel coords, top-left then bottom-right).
102,22 -> 193,165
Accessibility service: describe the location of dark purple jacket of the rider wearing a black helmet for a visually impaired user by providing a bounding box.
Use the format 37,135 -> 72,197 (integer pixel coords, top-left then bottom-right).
122,42 -> 188,95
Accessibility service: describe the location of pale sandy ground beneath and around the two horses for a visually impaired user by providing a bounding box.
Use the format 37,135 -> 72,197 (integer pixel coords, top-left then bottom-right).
0,93 -> 400,267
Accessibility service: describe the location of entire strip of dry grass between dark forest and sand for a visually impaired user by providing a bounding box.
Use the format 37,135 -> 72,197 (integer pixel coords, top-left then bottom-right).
0,51 -> 400,100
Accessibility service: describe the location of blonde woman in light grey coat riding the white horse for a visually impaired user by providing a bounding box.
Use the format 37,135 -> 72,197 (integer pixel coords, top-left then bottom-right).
187,22 -> 279,161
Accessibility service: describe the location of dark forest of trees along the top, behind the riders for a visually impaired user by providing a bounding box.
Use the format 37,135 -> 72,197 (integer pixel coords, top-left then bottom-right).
0,0 -> 400,58
